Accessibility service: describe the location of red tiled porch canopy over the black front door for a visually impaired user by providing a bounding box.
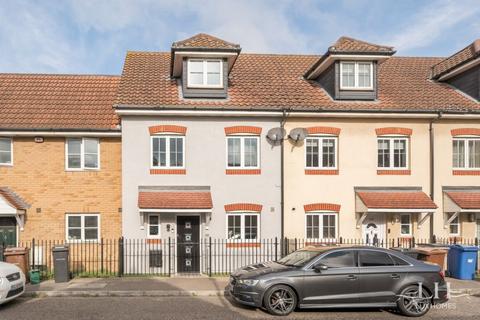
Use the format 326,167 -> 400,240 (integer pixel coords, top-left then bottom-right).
138,186 -> 213,212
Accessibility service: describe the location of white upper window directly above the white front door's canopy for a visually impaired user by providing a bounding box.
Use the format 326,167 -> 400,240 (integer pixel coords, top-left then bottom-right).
377,137 -> 408,169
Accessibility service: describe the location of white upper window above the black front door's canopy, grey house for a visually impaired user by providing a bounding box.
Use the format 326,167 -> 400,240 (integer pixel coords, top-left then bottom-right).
150,135 -> 185,169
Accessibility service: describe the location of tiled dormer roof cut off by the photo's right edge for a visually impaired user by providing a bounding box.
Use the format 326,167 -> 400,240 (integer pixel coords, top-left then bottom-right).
431,39 -> 480,81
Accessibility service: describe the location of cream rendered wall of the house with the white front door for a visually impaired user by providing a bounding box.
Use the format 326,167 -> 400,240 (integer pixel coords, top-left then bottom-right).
284,118 -> 437,238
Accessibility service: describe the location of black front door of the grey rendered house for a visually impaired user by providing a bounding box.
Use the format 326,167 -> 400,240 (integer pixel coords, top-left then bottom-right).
177,216 -> 200,273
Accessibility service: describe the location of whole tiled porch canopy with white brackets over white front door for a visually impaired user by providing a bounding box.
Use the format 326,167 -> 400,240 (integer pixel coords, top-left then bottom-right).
355,187 -> 438,227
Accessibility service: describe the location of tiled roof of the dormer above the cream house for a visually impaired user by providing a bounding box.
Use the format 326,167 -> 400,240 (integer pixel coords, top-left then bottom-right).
304,37 -> 396,80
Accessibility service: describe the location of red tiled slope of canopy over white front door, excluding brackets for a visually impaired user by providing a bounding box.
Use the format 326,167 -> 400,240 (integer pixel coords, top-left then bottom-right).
356,190 -> 437,212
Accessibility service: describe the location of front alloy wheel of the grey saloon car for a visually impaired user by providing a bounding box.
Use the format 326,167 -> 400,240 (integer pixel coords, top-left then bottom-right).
265,285 -> 297,316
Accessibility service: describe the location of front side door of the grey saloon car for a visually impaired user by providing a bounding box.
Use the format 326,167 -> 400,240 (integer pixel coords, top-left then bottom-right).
301,250 -> 359,307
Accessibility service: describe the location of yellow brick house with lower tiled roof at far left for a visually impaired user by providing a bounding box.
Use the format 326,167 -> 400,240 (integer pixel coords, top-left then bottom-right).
0,74 -> 121,246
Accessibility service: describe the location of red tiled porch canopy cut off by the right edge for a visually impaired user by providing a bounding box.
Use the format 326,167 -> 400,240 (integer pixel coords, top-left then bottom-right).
443,189 -> 480,212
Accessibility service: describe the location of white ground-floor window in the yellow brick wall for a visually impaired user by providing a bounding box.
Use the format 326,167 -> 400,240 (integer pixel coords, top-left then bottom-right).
65,213 -> 100,242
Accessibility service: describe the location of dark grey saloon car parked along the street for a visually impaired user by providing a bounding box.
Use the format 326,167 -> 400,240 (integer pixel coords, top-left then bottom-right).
228,247 -> 448,317
